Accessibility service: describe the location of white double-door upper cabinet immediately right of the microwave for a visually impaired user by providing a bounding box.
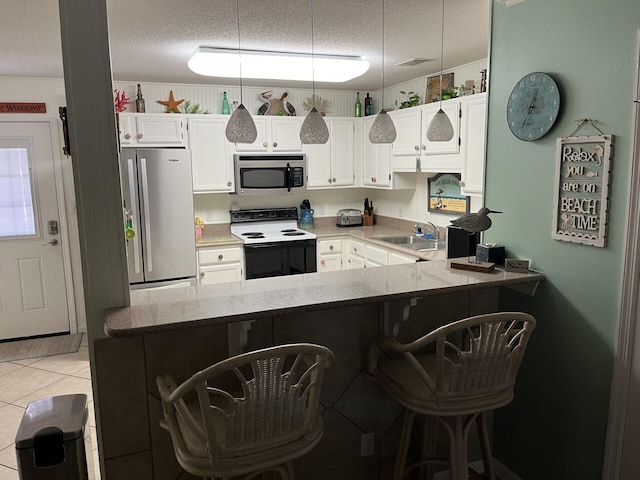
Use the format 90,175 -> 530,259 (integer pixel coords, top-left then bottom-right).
304,118 -> 356,189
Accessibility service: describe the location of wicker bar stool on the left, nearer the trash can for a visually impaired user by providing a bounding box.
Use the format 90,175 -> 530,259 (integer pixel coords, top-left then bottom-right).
156,343 -> 335,480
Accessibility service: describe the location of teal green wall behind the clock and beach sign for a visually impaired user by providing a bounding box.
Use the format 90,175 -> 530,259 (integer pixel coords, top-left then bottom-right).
485,0 -> 640,480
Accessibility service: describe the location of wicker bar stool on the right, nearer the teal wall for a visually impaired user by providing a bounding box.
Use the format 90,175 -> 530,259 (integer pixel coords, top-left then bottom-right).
370,312 -> 536,480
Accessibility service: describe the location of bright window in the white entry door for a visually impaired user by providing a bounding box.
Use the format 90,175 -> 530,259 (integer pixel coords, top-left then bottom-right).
0,148 -> 36,237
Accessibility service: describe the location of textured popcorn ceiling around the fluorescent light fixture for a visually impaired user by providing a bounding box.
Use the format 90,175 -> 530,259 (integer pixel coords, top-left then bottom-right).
0,0 -> 490,90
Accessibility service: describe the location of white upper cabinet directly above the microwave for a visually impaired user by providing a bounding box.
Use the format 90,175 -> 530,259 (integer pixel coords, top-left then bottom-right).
236,116 -> 304,152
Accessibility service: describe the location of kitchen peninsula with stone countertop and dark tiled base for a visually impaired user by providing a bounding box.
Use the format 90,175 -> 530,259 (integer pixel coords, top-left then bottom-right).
96,260 -> 544,480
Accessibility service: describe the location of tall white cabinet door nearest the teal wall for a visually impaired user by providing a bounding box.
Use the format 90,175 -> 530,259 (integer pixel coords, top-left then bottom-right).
460,93 -> 487,195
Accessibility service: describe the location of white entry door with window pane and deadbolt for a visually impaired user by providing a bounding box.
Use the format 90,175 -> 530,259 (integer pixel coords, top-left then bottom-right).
0,122 -> 69,339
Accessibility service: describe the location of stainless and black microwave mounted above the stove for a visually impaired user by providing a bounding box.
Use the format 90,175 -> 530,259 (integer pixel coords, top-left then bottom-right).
233,153 -> 307,195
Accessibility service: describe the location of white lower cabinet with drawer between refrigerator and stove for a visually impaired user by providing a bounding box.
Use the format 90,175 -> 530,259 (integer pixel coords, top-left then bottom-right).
198,246 -> 244,285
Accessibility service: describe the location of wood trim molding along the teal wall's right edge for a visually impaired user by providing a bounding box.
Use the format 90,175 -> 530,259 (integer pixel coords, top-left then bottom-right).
602,29 -> 640,478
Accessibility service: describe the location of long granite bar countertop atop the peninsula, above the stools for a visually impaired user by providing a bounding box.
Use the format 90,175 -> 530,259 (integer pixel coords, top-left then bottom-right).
105,260 -> 544,337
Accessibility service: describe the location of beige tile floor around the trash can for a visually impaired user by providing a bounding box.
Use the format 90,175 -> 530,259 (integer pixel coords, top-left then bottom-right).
0,338 -> 99,480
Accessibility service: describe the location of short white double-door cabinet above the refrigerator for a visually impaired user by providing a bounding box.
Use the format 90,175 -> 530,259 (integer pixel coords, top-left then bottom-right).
119,113 -> 187,147
